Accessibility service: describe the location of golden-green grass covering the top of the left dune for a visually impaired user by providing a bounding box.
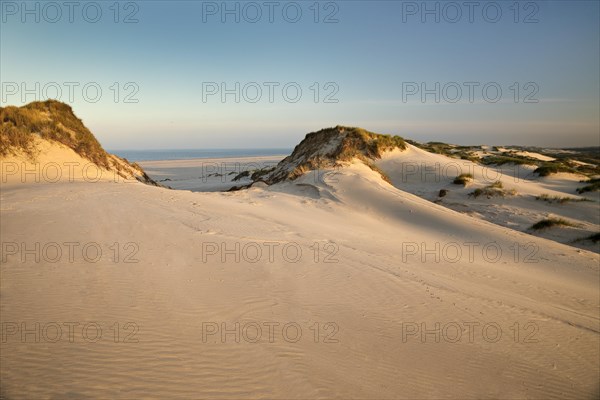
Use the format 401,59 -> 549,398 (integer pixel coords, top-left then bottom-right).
0,100 -> 110,168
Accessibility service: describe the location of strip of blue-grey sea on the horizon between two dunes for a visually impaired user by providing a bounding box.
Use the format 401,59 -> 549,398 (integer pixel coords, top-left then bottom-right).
112,148 -> 293,162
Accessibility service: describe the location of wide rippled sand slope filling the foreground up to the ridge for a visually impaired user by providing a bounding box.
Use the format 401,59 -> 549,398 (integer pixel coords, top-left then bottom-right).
0,158 -> 600,399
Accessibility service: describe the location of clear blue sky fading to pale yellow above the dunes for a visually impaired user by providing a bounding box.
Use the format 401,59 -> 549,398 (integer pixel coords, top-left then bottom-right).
0,0 -> 600,149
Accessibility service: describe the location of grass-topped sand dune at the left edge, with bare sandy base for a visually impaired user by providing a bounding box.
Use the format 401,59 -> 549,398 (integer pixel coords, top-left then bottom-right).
0,100 -> 154,184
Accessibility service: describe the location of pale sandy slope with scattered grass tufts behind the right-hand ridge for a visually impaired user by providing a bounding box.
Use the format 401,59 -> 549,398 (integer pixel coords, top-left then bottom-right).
376,145 -> 600,252
